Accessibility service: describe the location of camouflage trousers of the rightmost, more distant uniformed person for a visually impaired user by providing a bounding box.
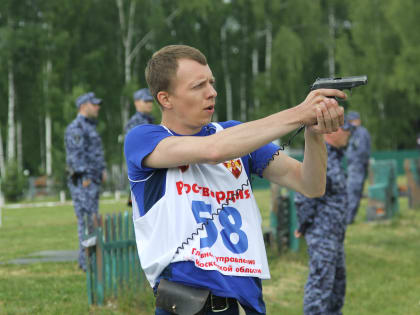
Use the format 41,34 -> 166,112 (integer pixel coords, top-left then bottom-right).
347,166 -> 367,224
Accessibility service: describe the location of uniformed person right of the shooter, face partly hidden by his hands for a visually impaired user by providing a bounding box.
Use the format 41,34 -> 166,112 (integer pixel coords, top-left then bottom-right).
295,122 -> 352,315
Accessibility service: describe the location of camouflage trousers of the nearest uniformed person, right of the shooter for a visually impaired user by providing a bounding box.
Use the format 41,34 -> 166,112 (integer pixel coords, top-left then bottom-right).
303,231 -> 346,315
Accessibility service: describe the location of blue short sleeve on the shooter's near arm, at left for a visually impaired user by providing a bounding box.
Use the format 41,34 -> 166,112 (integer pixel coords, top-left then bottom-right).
124,124 -> 172,181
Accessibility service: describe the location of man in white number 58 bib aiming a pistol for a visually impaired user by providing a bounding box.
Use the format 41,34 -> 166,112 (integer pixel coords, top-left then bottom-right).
124,45 -> 346,314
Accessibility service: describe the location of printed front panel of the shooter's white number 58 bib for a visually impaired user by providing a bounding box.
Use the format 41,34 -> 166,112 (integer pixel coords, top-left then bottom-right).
168,159 -> 269,278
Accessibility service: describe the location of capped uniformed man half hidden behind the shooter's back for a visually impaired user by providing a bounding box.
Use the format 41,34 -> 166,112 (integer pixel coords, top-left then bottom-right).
124,88 -> 153,133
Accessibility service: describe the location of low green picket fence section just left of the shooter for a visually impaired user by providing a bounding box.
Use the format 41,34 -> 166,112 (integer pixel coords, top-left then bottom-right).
85,211 -> 145,305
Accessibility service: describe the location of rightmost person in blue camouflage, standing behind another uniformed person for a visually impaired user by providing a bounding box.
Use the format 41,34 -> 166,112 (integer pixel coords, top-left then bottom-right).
346,112 -> 370,224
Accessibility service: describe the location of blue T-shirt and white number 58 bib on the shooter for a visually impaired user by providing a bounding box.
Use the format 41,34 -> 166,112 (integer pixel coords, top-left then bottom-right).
125,121 -> 278,313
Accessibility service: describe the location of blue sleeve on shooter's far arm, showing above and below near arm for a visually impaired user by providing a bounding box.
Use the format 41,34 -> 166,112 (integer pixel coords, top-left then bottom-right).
220,120 -> 280,177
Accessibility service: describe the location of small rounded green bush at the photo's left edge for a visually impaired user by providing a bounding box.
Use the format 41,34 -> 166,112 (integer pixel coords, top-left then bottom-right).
1,161 -> 28,202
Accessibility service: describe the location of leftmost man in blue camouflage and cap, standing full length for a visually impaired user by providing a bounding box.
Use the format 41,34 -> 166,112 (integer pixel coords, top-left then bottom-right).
64,92 -> 105,271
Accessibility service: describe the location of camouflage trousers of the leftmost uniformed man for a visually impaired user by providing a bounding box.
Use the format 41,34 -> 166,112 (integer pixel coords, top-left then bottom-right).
68,181 -> 100,271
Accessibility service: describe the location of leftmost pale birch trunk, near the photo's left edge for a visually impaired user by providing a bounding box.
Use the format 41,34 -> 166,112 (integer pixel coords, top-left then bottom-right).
7,61 -> 16,162
